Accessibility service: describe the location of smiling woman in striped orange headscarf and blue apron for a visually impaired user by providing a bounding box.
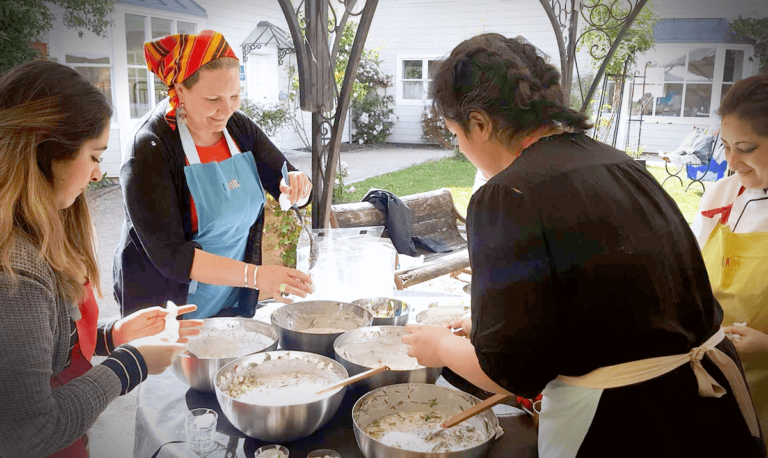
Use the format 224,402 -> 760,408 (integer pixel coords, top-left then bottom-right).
113,30 -> 312,318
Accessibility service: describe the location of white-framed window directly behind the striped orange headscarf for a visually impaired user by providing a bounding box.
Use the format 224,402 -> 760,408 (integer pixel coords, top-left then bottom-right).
125,13 -> 197,119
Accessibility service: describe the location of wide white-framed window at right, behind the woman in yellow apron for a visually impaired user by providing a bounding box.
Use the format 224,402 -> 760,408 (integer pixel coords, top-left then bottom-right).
632,43 -> 748,119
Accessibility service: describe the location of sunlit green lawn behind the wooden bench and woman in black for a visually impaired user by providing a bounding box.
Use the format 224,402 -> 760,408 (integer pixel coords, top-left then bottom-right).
344,158 -> 702,224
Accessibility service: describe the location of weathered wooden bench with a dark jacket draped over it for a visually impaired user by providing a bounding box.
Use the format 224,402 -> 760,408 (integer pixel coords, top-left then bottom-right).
331,188 -> 469,289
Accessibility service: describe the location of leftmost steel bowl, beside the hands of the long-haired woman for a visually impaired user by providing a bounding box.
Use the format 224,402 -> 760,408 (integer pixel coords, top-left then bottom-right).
171,318 -> 278,393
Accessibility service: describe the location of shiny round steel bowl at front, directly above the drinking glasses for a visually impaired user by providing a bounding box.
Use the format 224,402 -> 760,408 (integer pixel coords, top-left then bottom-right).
215,351 -> 348,443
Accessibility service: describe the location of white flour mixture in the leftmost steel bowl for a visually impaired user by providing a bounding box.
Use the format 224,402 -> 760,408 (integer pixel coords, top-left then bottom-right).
187,328 -> 275,358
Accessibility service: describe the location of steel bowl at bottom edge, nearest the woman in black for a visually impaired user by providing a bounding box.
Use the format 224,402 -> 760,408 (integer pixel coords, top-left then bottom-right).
352,383 -> 503,458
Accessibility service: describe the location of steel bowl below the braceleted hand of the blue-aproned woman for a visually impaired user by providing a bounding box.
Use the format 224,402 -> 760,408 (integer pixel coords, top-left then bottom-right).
271,301 -> 373,358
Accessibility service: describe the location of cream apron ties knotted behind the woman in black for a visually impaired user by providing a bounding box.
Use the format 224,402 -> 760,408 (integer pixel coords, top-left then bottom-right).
557,327 -> 760,437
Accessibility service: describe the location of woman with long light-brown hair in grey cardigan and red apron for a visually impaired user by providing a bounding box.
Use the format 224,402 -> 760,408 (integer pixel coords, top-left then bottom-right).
0,62 -> 201,458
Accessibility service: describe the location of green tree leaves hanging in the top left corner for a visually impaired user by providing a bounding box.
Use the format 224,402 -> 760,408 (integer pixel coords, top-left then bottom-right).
0,0 -> 114,74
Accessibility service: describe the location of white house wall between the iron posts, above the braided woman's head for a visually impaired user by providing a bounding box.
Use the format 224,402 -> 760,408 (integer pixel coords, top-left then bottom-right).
366,0 -> 559,143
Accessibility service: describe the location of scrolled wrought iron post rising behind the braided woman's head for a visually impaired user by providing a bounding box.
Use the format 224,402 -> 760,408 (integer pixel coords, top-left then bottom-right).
539,0 -> 648,111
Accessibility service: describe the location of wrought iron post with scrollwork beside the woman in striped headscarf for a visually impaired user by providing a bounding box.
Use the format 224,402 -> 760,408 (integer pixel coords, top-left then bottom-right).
278,0 -> 379,228
